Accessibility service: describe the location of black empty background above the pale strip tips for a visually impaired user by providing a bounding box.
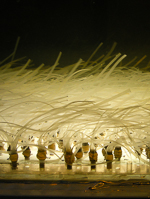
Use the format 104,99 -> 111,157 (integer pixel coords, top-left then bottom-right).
0,0 -> 150,66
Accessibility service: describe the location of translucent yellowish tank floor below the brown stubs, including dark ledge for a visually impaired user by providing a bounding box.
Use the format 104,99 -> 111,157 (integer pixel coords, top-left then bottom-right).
0,148 -> 150,198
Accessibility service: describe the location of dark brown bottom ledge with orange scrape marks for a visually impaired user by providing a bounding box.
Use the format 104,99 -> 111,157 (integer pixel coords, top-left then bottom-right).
0,180 -> 150,198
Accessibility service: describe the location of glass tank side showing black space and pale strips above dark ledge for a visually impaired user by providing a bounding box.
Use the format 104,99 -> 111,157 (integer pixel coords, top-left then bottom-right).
0,0 -> 150,180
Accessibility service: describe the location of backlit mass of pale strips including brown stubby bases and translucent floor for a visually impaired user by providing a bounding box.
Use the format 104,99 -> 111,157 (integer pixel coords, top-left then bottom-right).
0,43 -> 150,180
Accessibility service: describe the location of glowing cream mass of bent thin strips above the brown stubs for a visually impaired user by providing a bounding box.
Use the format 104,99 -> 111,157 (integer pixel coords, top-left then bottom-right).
0,42 -> 150,174
